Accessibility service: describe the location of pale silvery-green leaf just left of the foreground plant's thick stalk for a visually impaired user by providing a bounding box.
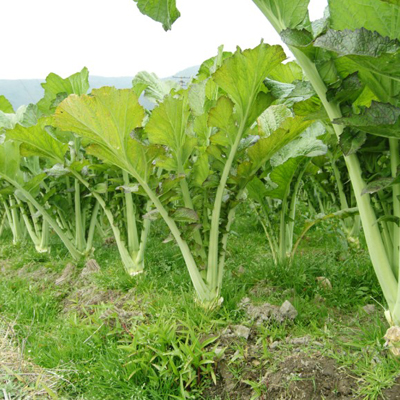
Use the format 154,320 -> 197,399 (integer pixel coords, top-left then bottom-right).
271,122 -> 328,167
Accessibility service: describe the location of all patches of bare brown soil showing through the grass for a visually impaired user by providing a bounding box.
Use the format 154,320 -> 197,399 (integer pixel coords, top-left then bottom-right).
0,264 -> 400,400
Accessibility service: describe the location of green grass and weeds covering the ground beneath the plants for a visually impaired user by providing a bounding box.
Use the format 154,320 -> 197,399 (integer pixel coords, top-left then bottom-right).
0,212 -> 400,399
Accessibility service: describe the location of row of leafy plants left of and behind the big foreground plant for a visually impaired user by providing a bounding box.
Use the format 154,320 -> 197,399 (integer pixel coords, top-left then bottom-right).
0,43 -> 352,305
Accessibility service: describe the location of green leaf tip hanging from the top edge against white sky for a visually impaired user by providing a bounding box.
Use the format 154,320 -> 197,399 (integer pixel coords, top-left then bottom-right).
134,0 -> 181,31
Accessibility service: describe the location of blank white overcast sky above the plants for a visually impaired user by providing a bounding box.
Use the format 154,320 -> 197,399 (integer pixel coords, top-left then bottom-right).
0,0 -> 327,79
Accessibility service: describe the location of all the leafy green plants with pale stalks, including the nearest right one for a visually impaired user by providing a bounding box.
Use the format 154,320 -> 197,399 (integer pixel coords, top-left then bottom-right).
0,0 -> 400,344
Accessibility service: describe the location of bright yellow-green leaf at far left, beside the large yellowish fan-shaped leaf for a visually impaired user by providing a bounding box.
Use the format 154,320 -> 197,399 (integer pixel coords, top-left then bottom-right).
6,119 -> 68,162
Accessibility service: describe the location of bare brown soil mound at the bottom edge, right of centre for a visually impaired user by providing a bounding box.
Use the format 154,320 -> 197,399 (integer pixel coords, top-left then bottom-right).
209,353 -> 360,400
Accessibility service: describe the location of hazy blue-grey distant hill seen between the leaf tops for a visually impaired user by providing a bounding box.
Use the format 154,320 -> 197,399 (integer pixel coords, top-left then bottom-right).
0,66 -> 199,110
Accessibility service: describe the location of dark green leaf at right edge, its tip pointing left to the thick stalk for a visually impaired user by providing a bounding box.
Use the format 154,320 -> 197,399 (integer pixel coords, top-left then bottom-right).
333,101 -> 400,138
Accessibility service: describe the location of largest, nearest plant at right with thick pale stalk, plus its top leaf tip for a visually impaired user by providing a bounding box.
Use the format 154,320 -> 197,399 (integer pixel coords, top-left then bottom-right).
131,0 -> 400,338
